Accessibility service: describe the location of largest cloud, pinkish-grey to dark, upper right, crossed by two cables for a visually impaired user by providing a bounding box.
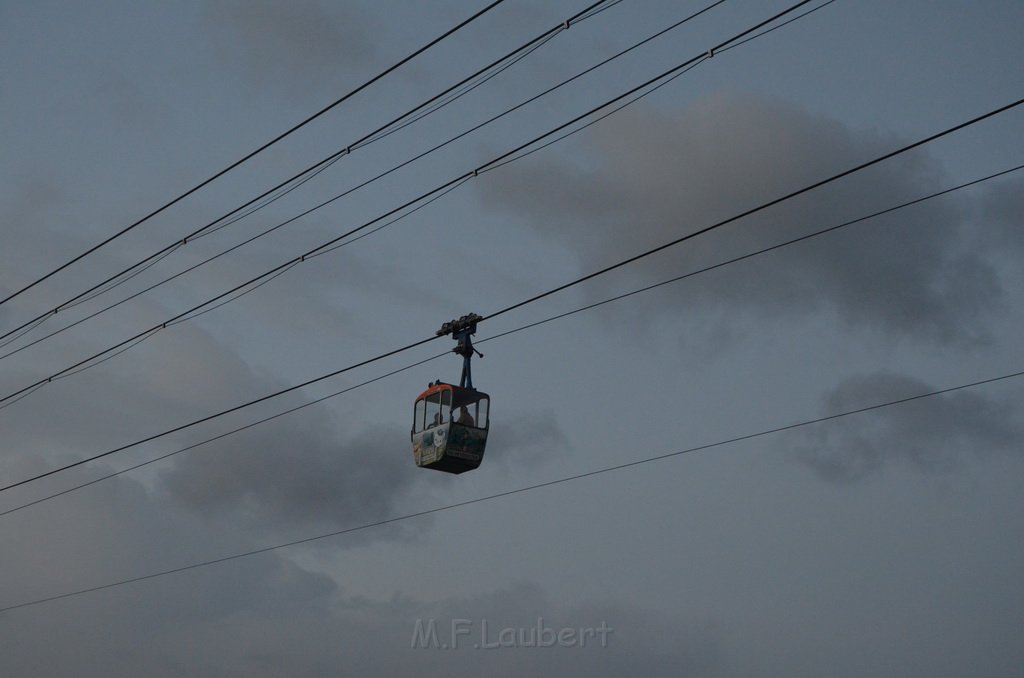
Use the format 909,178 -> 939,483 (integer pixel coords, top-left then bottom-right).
481,94 -> 1005,343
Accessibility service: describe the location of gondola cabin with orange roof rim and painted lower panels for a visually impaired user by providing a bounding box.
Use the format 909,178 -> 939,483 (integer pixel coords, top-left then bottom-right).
412,382 -> 490,473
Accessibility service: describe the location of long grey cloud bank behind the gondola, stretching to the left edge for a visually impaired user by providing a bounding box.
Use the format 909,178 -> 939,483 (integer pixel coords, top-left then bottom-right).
0,280 -> 564,543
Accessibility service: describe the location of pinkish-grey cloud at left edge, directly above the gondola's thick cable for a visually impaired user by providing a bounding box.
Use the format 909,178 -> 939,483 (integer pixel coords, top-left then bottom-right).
0,324 -> 282,478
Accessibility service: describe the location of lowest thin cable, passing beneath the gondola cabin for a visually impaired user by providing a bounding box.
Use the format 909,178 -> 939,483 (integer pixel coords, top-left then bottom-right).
0,371 -> 1024,612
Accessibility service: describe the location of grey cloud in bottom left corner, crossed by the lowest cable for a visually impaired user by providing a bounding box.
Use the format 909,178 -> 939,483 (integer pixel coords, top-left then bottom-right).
0,462 -> 338,676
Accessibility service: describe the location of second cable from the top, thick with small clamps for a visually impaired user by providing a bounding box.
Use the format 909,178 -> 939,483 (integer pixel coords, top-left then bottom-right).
0,0 -> 617,348
